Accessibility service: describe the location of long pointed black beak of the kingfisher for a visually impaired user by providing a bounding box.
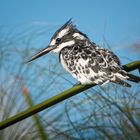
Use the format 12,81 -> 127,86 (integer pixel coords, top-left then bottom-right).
26,46 -> 55,63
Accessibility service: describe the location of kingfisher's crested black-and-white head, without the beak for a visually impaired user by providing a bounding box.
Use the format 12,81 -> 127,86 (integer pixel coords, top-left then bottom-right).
49,19 -> 87,53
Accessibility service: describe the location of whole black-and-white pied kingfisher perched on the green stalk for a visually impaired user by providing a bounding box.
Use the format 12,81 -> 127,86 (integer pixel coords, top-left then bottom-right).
27,19 -> 140,87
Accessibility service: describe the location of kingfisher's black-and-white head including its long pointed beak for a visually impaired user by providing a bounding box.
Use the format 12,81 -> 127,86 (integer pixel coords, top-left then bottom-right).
27,19 -> 88,62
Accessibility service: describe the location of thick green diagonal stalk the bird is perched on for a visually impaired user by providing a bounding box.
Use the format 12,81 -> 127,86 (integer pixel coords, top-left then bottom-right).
0,61 -> 140,130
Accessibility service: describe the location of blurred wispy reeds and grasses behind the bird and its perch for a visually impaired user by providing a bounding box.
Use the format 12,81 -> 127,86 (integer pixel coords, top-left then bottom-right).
0,23 -> 140,140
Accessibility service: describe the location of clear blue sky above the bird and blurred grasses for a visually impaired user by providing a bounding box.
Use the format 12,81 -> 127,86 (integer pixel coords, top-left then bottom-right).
0,0 -> 140,60
